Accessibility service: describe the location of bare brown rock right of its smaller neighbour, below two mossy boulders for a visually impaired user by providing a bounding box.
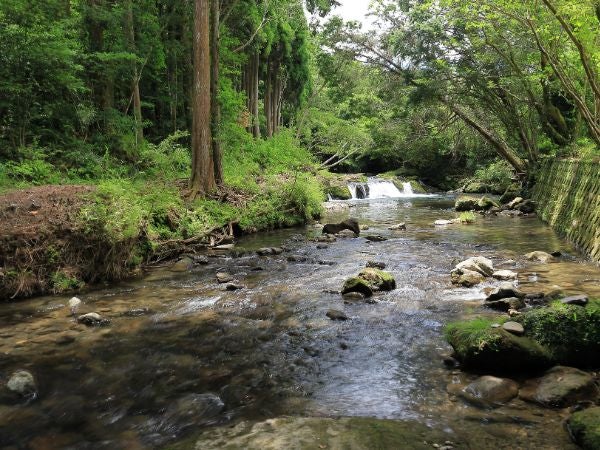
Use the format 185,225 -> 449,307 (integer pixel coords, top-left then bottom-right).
519,366 -> 599,408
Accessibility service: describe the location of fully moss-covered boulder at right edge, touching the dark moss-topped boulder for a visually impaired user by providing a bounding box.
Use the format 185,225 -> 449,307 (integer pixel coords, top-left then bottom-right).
515,299 -> 600,367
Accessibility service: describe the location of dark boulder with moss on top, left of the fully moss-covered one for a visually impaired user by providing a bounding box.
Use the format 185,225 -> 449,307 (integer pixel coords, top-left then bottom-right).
446,319 -> 552,373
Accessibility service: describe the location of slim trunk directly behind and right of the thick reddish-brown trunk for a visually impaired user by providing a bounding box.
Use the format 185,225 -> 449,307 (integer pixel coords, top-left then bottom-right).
210,0 -> 223,184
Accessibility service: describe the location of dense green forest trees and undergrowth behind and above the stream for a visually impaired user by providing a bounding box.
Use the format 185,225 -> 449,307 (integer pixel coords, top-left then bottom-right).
0,0 -> 600,294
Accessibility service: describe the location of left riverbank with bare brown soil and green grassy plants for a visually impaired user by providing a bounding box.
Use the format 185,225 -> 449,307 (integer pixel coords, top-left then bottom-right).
0,173 -> 323,299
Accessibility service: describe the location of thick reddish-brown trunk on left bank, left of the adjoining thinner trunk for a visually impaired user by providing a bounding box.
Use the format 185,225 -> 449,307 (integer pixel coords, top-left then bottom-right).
190,0 -> 216,198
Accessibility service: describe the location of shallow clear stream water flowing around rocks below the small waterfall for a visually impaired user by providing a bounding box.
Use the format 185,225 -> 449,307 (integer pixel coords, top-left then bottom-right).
0,196 -> 600,449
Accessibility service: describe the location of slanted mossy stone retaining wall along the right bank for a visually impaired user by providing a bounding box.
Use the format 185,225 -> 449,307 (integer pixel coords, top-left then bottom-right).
533,160 -> 600,261
